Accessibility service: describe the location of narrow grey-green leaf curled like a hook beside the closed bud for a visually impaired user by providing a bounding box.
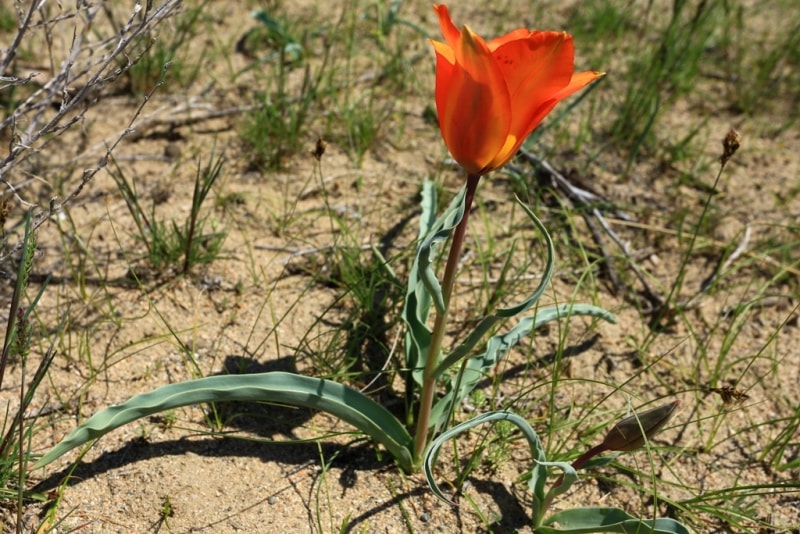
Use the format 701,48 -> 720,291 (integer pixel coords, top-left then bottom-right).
423,411 -> 547,509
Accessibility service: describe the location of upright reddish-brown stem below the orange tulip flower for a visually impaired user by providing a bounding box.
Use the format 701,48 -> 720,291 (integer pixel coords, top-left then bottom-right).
414,174 -> 480,466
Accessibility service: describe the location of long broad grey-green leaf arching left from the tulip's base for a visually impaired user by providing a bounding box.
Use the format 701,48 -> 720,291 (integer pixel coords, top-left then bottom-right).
33,372 -> 413,472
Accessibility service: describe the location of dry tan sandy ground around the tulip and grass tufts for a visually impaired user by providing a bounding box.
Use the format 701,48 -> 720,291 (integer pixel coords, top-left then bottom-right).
0,1 -> 800,533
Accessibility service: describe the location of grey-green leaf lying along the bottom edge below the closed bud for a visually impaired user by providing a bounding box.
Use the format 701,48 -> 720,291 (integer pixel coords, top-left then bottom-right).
536,506 -> 689,534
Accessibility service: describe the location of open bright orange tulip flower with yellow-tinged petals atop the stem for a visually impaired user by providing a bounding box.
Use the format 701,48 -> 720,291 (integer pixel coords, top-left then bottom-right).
431,5 -> 603,175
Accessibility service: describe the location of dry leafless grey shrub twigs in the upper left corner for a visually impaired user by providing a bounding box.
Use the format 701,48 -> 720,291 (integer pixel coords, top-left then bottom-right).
0,0 -> 181,262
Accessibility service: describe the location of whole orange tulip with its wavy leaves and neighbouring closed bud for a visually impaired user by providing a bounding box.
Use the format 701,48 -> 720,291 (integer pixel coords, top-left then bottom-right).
34,5 -> 687,533
